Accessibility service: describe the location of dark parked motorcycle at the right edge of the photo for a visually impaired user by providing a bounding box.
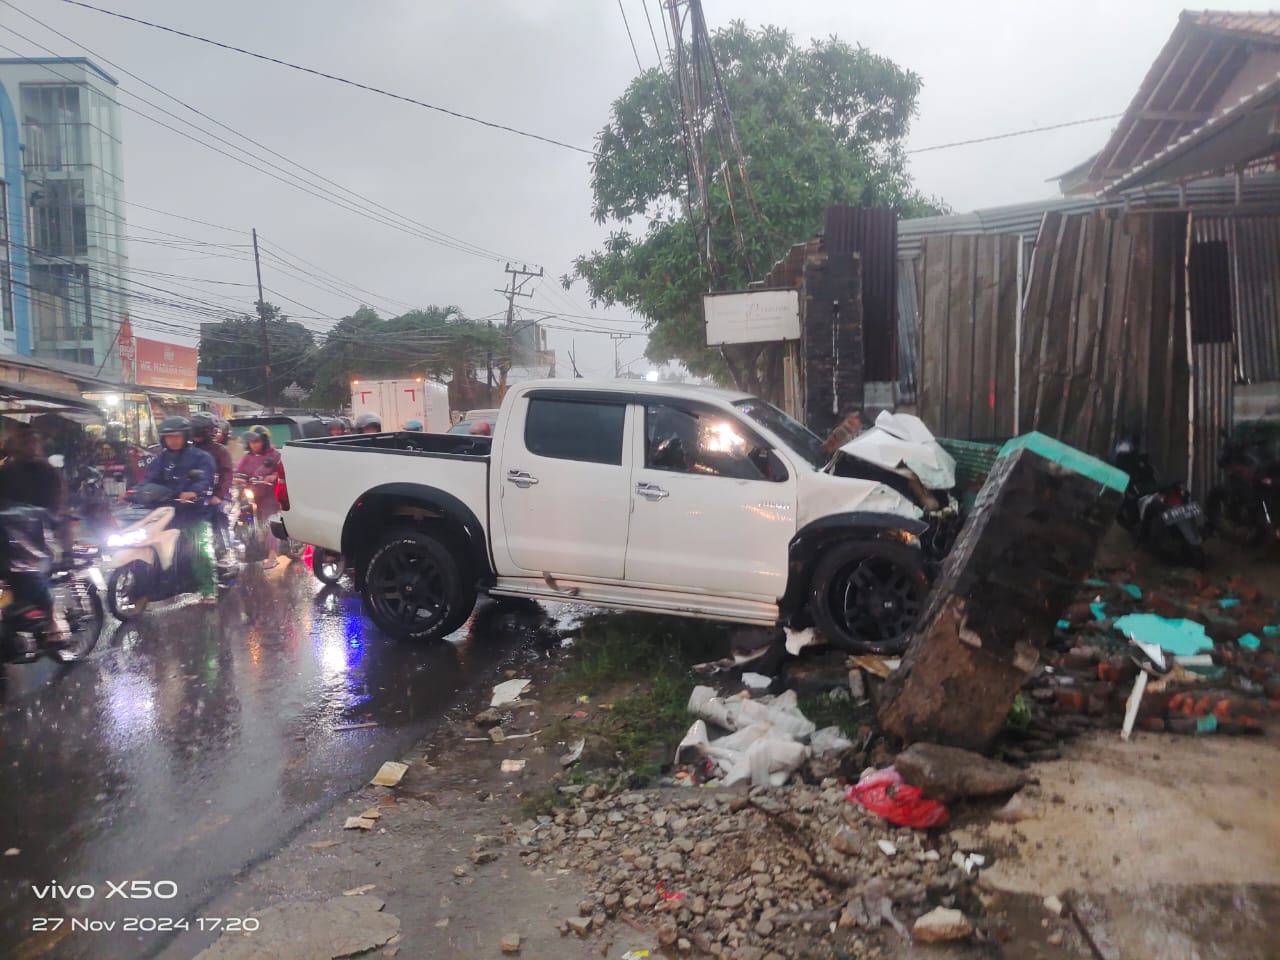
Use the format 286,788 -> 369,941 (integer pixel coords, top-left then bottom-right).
1208,430 -> 1280,547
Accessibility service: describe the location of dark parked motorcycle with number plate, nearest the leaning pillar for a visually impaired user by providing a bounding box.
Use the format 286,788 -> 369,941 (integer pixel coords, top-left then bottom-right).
1111,436 -> 1204,568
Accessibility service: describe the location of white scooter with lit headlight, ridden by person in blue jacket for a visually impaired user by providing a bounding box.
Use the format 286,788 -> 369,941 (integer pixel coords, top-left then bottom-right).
106,484 -> 228,621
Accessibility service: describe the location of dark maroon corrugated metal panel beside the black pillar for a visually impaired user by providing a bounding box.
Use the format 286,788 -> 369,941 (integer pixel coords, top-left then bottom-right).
823,206 -> 899,381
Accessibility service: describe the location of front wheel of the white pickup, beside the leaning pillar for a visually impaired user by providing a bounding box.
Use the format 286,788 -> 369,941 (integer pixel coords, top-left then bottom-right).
809,540 -> 929,655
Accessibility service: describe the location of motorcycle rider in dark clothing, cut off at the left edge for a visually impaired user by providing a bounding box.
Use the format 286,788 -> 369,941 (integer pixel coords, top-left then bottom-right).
0,426 -> 70,643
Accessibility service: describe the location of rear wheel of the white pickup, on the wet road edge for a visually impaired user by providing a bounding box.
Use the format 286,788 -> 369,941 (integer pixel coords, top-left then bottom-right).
361,527 -> 476,641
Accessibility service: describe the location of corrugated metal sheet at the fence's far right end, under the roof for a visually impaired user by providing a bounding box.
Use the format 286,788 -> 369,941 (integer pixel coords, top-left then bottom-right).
1192,215 -> 1280,383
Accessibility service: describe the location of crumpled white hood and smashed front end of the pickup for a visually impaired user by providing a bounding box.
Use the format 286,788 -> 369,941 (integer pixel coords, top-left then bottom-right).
831,411 -> 964,561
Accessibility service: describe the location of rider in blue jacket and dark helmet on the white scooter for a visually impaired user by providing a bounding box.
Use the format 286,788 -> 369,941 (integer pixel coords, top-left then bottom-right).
143,416 -> 218,603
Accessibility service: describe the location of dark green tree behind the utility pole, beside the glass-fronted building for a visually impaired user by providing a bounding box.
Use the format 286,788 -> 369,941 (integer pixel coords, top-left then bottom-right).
200,303 -> 315,406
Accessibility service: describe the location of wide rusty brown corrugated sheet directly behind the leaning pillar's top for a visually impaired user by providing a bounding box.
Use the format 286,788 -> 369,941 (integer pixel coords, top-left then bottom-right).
1019,211 -> 1193,477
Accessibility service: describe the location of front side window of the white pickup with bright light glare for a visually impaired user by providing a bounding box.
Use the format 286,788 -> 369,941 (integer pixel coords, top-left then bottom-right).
644,403 -> 787,483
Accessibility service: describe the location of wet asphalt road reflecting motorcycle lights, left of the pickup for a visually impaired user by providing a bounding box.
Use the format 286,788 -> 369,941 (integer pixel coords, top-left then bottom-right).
0,563 -> 529,960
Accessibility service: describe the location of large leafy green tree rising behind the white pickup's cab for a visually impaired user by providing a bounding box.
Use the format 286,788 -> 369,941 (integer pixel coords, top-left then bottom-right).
576,22 -> 940,394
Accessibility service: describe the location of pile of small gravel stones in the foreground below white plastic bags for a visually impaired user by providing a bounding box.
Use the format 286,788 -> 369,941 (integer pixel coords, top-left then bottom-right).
517,781 -> 986,960
